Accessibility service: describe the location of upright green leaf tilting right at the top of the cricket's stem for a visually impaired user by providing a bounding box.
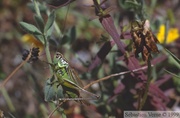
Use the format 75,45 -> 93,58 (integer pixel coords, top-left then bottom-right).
44,10 -> 56,33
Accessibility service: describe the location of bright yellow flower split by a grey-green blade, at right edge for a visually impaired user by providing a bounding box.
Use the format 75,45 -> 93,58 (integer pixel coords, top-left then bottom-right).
157,24 -> 180,44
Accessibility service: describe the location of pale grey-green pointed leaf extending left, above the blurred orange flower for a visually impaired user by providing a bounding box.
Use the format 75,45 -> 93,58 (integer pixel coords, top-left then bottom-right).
20,22 -> 42,35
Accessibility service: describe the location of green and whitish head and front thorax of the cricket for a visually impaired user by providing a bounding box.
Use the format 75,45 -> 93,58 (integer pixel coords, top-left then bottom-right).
54,52 -> 69,67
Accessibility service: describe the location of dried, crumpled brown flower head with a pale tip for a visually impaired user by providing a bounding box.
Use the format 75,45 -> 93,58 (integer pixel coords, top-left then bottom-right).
131,20 -> 159,61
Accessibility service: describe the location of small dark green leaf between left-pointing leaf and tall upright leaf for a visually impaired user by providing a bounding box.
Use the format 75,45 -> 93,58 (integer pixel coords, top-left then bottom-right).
34,15 -> 44,32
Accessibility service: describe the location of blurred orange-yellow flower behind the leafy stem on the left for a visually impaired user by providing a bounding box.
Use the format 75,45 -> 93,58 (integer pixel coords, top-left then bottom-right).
21,34 -> 44,53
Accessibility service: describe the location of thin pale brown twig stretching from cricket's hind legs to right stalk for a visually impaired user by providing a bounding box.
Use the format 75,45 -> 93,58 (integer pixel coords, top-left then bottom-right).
84,66 -> 150,89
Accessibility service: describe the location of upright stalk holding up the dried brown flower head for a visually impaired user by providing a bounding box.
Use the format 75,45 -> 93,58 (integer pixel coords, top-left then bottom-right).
138,57 -> 152,111
